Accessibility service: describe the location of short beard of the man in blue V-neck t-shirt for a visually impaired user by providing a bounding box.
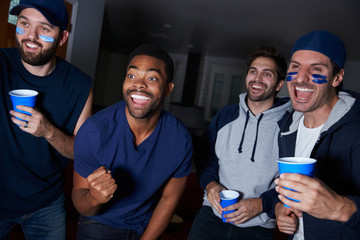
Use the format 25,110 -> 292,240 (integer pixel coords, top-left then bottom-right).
124,90 -> 164,119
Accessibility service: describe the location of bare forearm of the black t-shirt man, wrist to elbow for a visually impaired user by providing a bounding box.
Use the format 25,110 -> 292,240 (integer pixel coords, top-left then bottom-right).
45,126 -> 75,159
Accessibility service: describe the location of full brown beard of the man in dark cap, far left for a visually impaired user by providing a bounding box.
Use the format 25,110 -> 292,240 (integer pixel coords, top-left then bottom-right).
16,38 -> 59,66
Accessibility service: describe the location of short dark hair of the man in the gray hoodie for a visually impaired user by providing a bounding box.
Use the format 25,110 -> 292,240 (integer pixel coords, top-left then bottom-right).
246,46 -> 287,82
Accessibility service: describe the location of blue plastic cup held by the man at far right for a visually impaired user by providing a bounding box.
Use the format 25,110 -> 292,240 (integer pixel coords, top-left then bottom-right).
278,157 -> 316,207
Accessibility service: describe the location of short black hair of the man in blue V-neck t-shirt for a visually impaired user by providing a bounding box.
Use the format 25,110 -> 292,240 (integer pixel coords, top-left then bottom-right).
128,44 -> 174,82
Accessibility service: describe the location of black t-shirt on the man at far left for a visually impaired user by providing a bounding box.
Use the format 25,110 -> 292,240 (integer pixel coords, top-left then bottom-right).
0,48 -> 92,218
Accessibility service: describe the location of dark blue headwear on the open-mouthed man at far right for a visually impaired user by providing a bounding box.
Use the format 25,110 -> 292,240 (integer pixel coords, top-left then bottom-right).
291,31 -> 346,68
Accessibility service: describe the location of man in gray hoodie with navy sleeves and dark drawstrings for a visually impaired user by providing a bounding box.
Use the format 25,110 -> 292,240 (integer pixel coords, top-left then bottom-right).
189,47 -> 291,240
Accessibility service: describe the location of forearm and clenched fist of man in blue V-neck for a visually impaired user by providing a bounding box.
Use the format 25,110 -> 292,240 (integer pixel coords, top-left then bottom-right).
72,167 -> 117,216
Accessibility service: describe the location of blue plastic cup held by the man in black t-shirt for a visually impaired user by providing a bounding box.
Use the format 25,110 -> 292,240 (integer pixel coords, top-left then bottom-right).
9,89 -> 38,121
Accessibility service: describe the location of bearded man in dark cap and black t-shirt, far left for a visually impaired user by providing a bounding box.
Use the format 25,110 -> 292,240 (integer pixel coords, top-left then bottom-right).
0,0 -> 92,240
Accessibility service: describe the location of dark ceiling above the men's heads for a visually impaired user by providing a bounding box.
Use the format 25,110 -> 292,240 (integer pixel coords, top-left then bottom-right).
102,0 -> 360,60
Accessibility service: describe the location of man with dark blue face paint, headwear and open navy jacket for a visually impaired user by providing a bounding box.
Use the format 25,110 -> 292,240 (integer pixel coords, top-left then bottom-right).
262,31 -> 360,240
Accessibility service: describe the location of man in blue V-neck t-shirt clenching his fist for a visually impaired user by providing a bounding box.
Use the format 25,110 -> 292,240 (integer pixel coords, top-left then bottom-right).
72,44 -> 192,240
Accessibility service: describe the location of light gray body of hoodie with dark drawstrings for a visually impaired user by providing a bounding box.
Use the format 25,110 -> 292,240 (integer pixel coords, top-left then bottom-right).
200,93 -> 291,228
